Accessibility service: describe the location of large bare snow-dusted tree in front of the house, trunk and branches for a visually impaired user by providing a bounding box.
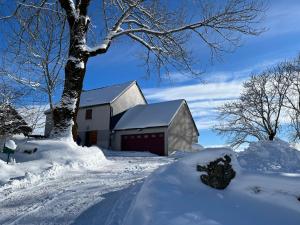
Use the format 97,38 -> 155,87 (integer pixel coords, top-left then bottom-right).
1,0 -> 264,140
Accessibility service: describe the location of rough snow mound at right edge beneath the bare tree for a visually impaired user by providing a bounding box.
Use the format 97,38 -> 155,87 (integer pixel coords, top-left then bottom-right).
238,140 -> 300,173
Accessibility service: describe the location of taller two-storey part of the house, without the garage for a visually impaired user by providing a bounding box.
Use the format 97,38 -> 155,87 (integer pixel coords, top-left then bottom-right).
45,81 -> 147,148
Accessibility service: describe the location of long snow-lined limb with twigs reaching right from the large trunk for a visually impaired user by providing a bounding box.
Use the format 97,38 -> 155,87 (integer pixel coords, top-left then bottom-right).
86,0 -> 264,77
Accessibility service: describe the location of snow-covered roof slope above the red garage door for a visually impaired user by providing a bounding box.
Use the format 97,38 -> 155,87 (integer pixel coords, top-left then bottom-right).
114,99 -> 185,130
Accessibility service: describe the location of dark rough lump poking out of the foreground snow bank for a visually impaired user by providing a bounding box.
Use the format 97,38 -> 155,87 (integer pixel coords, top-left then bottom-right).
197,155 -> 235,189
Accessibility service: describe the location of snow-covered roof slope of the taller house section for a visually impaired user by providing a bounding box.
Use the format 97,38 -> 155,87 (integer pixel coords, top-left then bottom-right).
79,81 -> 136,107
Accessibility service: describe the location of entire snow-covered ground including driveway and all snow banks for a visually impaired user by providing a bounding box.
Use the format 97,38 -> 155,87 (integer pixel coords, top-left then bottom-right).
0,140 -> 300,225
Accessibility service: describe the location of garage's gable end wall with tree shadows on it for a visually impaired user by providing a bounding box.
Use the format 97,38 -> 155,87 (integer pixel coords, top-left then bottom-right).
167,104 -> 198,154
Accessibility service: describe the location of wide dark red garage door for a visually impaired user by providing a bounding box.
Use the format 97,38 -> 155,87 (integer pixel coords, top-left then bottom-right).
121,133 -> 165,155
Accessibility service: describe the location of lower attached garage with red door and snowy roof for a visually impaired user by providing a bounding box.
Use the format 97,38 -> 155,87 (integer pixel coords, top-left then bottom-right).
111,100 -> 199,156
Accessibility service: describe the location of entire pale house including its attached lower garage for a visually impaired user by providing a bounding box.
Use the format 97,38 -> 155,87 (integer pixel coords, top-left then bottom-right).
45,81 -> 199,155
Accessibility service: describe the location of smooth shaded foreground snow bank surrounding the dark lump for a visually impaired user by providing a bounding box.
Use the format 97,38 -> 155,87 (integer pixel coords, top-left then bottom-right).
122,149 -> 300,225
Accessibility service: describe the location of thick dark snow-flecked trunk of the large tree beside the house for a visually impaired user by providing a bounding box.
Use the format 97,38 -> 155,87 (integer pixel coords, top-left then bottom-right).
51,16 -> 88,140
